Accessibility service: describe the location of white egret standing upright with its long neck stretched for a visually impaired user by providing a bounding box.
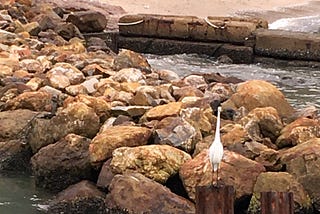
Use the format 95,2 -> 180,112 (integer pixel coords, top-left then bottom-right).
209,106 -> 223,183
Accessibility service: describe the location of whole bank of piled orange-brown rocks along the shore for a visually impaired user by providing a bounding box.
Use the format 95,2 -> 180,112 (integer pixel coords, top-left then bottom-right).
0,0 -> 320,213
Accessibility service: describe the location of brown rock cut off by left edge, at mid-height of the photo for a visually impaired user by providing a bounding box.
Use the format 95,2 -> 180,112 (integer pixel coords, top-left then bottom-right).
0,109 -> 39,142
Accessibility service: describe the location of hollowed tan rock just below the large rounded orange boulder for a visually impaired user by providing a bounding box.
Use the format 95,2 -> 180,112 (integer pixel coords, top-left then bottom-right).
240,107 -> 283,142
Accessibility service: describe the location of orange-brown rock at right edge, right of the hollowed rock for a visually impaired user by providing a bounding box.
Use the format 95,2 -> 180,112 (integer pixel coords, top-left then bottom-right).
276,117 -> 320,148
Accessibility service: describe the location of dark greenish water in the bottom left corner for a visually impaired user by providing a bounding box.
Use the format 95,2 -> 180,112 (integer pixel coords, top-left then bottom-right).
0,173 -> 51,214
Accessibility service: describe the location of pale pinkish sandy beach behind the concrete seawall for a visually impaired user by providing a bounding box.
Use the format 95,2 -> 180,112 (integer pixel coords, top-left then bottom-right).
104,0 -> 320,21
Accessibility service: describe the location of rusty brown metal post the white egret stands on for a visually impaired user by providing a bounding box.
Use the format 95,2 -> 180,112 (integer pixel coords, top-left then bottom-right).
196,185 -> 235,214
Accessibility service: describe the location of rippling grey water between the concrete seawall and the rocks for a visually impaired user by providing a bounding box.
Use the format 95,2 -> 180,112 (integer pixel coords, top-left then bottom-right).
146,54 -> 320,109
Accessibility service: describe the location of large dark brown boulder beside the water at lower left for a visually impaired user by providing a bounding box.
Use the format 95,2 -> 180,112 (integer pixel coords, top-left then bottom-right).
31,134 -> 94,192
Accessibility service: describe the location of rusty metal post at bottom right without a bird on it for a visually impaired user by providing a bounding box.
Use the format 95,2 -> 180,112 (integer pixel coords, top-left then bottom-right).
260,192 -> 294,214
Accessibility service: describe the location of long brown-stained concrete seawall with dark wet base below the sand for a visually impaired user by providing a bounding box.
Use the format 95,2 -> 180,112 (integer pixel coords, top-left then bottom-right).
102,14 -> 320,67
